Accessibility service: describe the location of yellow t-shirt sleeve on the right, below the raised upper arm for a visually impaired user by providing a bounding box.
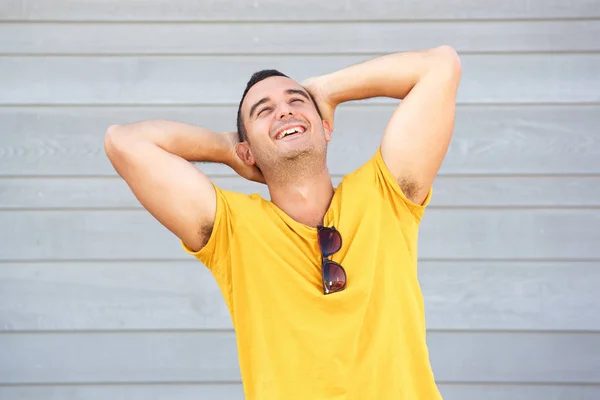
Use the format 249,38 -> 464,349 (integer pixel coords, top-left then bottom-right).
365,149 -> 433,223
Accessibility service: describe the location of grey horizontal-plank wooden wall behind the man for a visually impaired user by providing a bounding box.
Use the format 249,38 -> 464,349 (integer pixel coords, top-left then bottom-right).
0,0 -> 600,400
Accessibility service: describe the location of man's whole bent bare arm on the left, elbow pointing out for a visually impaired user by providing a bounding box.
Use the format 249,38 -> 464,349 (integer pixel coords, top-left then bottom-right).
104,121 -> 253,251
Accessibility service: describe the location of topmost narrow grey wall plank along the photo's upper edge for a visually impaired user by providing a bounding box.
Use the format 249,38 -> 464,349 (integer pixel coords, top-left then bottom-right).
0,0 -> 600,21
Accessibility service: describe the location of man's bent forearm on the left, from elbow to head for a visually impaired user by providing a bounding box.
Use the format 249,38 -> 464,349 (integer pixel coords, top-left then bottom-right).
106,120 -> 231,163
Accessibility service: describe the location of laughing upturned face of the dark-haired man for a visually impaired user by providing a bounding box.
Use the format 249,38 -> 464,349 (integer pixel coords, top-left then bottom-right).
238,76 -> 331,174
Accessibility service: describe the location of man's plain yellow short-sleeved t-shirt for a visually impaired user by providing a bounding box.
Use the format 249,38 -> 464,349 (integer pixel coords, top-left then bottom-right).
182,151 -> 441,400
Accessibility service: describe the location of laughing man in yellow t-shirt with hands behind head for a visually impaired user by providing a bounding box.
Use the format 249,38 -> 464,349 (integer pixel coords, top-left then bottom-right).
105,46 -> 461,400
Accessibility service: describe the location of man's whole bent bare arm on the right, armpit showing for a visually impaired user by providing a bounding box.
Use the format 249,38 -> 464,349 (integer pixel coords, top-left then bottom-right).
309,46 -> 461,204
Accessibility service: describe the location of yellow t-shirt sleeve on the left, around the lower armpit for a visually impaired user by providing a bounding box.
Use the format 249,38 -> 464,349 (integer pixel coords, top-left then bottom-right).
181,184 -> 233,275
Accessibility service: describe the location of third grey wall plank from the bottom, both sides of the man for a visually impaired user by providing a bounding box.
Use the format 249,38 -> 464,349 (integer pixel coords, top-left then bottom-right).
0,261 -> 600,332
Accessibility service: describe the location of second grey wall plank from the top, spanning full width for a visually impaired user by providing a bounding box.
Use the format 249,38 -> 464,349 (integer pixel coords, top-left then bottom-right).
0,21 -> 600,55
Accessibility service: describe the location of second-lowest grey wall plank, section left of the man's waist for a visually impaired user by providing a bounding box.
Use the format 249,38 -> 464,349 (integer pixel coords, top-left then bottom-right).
0,332 -> 240,384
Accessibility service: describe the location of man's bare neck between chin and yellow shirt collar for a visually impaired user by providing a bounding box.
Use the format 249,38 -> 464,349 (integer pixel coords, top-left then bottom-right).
268,159 -> 333,227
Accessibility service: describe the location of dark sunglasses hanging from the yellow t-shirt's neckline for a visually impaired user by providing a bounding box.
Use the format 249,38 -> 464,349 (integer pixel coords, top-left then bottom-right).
317,226 -> 346,294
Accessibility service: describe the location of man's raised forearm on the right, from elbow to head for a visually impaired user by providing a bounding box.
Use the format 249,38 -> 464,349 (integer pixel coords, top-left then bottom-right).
322,46 -> 458,105
